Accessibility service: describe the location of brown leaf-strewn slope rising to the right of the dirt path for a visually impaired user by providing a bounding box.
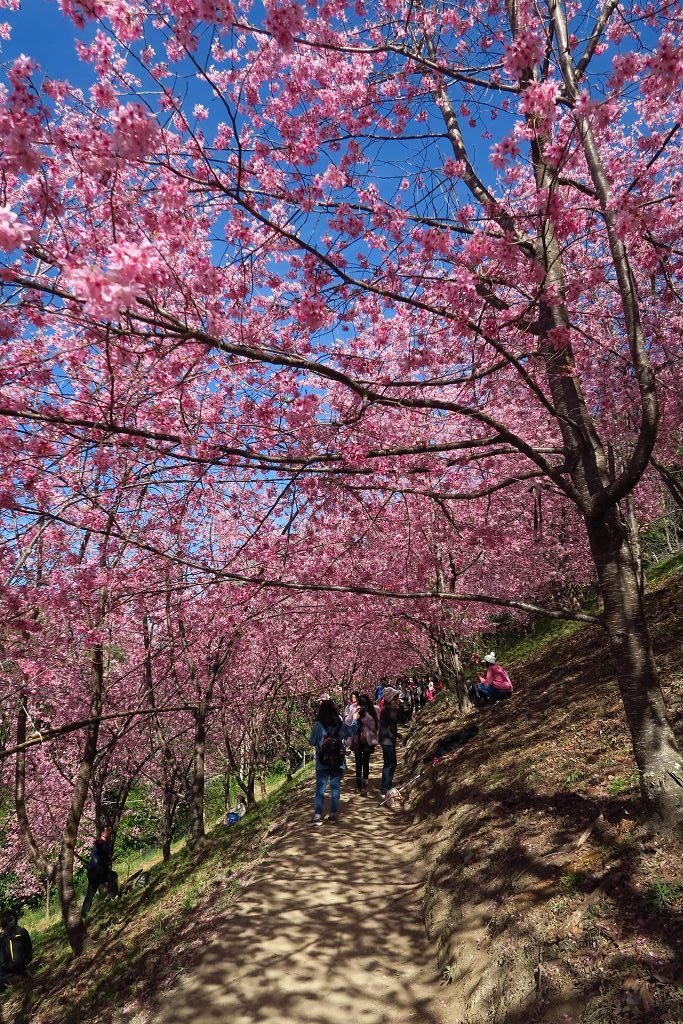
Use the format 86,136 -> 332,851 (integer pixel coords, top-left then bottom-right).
408,569 -> 683,1024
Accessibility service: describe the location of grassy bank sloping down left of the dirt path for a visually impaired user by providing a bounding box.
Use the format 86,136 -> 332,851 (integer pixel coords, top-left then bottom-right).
7,767 -> 310,1024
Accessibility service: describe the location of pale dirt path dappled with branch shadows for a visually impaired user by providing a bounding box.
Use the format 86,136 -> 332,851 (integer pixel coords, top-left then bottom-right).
155,759 -> 456,1024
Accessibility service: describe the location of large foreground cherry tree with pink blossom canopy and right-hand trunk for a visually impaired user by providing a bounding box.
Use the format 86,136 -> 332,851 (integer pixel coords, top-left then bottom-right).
0,0 -> 683,856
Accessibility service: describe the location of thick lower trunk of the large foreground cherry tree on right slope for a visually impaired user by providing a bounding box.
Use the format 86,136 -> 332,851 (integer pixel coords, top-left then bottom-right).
588,509 -> 683,830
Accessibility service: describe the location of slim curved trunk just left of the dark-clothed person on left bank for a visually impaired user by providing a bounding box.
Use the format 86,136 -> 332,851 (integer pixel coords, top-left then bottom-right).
57,644 -> 104,956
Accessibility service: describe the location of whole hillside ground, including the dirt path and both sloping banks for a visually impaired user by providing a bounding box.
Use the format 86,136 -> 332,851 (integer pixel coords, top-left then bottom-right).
5,570 -> 683,1024
